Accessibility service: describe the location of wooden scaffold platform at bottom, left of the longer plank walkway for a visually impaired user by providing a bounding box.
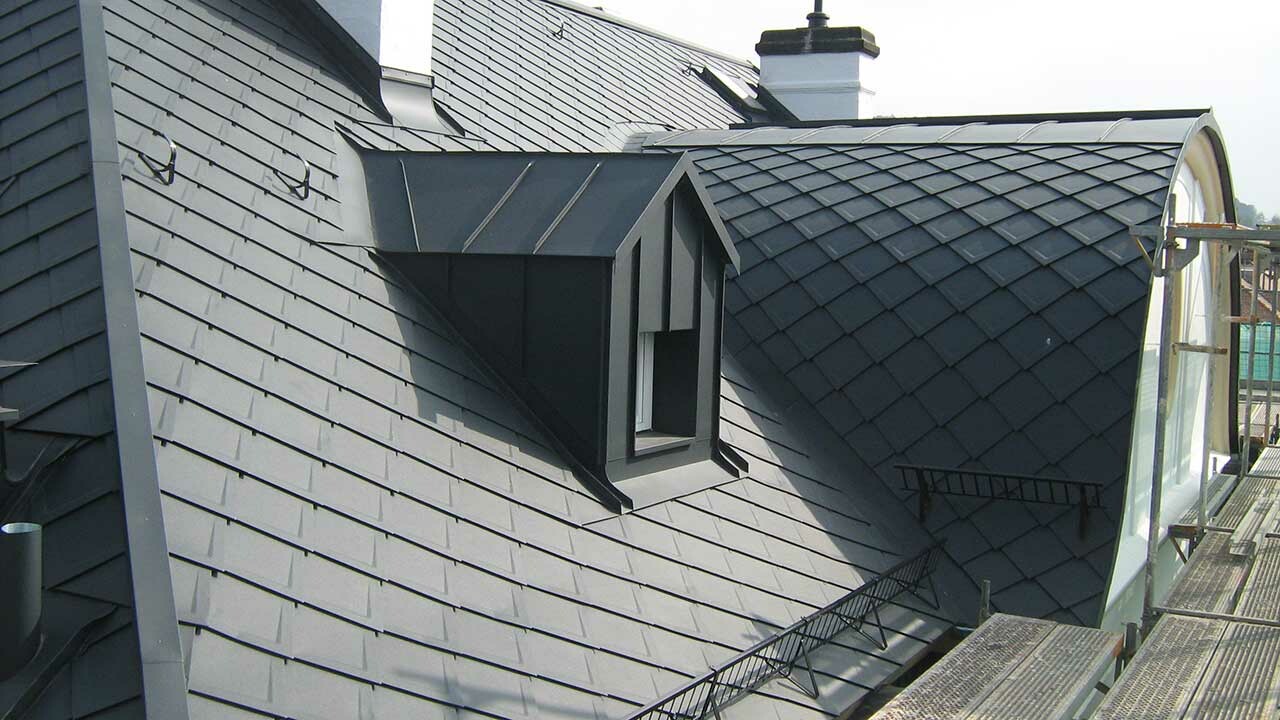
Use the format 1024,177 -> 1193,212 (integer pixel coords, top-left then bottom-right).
873,614 -> 1123,720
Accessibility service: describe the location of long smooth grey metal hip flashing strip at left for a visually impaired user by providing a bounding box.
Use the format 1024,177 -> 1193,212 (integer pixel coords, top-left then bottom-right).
79,0 -> 187,720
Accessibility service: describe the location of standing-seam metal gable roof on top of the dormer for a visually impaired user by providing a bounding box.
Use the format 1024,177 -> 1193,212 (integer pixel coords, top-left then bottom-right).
362,151 -> 737,263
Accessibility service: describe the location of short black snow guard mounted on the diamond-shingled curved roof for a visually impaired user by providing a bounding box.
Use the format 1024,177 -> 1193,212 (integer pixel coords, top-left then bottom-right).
893,465 -> 1102,536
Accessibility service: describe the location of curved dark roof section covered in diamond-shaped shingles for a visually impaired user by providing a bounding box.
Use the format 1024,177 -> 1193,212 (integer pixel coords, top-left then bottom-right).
643,120 -> 1202,624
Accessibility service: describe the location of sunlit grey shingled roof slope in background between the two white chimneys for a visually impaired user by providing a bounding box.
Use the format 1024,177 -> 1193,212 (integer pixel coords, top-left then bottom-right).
431,0 -> 756,151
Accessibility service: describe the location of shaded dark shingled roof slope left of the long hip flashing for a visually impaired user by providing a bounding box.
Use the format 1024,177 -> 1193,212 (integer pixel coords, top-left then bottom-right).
0,0 -> 142,719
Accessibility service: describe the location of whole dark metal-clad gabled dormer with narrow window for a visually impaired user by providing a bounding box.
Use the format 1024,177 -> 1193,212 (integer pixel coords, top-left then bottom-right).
360,151 -> 737,509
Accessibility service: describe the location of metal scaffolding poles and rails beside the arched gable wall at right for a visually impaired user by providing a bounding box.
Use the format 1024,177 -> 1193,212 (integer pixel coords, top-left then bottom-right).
1130,209 -> 1280,634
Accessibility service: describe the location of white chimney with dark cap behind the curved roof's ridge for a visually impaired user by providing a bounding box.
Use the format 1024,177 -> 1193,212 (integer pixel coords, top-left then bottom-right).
755,0 -> 879,120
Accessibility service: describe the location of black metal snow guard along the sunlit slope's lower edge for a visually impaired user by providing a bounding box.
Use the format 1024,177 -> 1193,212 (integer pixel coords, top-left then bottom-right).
628,546 -> 940,720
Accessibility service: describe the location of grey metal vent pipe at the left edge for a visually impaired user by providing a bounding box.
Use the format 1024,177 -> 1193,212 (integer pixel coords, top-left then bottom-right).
0,523 -> 45,680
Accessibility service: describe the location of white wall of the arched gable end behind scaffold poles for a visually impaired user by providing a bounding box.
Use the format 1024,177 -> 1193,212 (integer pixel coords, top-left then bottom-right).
1103,130 -> 1230,628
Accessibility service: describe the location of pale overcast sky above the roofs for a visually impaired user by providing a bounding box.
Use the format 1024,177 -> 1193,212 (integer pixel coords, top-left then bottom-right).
599,0 -> 1280,214
